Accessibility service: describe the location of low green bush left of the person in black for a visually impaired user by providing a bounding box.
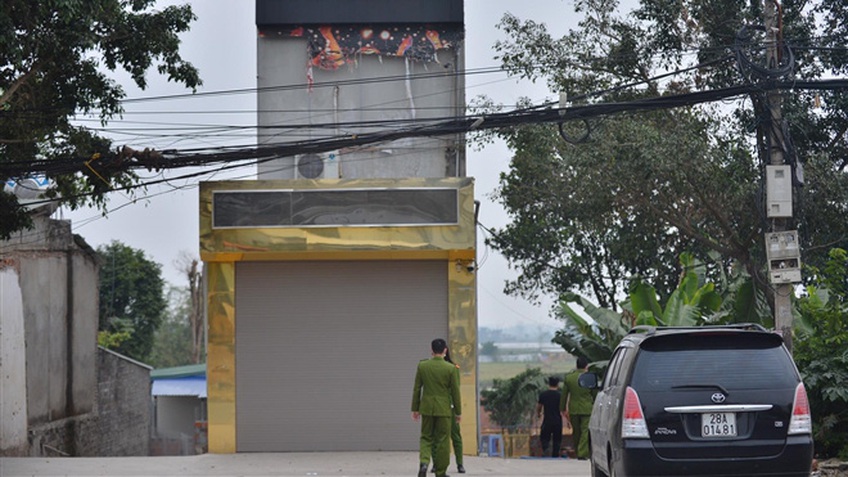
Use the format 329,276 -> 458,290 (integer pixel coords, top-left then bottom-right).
480,368 -> 546,431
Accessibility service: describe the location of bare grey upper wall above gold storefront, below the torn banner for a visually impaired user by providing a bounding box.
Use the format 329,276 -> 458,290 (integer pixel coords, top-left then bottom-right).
257,34 -> 465,179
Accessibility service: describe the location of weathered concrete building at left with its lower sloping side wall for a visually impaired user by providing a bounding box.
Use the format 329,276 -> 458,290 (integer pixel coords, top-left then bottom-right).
0,209 -> 150,456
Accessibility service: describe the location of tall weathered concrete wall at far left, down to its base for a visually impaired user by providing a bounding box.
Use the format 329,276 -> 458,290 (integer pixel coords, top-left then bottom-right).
0,213 -> 101,455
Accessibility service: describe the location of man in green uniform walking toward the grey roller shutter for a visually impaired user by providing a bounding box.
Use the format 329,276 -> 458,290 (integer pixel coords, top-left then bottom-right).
412,338 -> 462,477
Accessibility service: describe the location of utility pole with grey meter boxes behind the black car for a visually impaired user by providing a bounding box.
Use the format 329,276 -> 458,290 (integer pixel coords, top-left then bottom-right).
763,0 -> 801,353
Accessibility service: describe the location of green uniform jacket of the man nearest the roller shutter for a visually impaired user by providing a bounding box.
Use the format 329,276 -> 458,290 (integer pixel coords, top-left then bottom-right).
412,356 -> 462,417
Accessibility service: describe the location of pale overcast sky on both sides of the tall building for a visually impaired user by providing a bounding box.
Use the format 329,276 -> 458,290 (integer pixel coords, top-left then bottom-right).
54,0 -> 576,333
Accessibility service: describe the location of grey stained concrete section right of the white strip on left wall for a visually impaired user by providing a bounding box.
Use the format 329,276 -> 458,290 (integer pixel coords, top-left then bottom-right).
10,217 -> 99,426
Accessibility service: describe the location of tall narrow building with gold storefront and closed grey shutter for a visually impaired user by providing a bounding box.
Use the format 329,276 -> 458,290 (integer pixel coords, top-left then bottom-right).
200,0 -> 478,453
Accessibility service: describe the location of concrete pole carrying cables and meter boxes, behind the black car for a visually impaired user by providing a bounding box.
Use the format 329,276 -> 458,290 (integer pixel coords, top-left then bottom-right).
763,0 -> 800,352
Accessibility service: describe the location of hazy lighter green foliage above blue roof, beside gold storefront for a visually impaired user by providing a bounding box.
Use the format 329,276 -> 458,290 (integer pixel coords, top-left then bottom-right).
147,286 -> 194,368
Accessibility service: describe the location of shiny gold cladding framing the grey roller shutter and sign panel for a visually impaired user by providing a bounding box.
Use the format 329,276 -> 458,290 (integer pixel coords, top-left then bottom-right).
200,178 -> 479,455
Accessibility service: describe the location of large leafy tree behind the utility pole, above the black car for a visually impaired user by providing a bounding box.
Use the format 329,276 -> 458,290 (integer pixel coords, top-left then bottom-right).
488,0 -> 848,309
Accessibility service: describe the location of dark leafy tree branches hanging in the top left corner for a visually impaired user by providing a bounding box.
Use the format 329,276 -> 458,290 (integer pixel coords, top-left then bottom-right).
0,0 -> 201,239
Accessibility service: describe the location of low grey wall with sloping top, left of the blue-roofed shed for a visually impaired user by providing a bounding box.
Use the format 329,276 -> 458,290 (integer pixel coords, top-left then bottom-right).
97,348 -> 152,456
